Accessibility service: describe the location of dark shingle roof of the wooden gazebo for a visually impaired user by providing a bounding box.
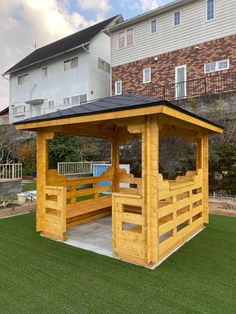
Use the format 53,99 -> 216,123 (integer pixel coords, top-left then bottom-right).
14,94 -> 222,128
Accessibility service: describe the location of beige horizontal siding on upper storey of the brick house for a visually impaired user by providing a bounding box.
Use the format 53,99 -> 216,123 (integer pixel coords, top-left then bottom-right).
112,0 -> 236,67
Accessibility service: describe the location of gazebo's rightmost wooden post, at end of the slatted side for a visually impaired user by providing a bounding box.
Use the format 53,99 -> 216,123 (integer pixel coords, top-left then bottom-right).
197,133 -> 209,224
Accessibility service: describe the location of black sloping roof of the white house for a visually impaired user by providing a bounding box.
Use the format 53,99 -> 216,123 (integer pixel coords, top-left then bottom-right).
4,15 -> 118,75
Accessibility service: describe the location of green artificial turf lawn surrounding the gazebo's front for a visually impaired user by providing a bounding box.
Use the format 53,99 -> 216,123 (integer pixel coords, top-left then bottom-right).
0,214 -> 236,314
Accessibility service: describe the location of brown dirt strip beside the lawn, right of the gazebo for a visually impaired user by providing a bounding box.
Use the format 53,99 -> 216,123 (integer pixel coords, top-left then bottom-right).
209,200 -> 236,217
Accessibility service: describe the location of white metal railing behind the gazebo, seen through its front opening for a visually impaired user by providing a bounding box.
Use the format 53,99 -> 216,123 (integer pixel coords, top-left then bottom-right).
57,161 -> 110,175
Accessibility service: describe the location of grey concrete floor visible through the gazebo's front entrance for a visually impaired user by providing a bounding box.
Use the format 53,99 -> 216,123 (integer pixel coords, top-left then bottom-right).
64,216 -> 112,257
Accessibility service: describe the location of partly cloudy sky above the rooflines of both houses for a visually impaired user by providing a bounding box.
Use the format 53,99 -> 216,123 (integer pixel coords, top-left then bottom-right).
0,0 -> 173,110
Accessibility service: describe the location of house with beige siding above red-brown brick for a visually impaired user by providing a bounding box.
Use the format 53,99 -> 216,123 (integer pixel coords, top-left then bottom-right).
109,0 -> 236,99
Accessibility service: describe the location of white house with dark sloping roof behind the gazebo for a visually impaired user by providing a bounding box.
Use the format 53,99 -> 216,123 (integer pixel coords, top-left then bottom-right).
3,15 -> 123,122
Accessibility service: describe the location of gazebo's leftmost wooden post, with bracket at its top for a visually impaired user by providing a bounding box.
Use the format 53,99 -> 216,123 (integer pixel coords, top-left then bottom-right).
36,131 -> 54,231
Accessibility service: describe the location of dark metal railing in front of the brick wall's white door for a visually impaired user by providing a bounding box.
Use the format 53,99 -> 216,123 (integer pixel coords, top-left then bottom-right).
135,72 -> 236,100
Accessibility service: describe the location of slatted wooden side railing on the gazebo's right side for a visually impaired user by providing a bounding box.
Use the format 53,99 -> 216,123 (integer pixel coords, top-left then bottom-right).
158,169 -> 203,260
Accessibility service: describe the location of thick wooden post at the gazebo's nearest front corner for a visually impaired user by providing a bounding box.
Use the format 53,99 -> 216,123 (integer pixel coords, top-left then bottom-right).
142,115 -> 159,264
